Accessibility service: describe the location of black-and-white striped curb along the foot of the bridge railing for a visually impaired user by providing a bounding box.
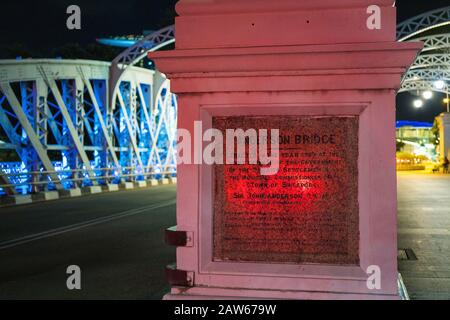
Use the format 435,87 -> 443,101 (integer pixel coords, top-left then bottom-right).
0,178 -> 177,208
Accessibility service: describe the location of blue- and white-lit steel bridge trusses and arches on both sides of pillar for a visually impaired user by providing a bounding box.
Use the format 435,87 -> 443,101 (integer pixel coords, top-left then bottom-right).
0,7 -> 450,196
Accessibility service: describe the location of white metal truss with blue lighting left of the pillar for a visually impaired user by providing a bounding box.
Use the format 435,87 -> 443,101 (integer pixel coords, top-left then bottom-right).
0,59 -> 177,194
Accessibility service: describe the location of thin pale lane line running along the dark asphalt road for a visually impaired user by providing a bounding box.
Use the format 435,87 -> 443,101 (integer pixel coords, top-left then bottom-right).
0,200 -> 176,250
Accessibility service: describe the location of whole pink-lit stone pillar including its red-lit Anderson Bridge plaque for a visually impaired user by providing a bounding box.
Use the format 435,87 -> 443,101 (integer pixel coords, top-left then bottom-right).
150,0 -> 422,299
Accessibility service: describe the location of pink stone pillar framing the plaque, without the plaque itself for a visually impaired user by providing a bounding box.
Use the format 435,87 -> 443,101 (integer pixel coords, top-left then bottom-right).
150,0 -> 421,299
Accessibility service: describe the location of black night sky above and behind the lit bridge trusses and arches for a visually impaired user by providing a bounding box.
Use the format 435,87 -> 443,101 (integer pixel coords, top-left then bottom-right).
0,0 -> 449,122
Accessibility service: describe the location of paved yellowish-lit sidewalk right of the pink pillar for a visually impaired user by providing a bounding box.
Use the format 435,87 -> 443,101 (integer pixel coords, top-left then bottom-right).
398,172 -> 450,299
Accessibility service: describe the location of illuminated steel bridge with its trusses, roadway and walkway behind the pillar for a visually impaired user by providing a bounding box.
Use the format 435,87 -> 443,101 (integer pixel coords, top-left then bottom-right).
0,7 -> 450,299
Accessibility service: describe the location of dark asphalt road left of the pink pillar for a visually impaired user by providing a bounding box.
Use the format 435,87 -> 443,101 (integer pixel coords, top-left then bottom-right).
0,186 -> 176,299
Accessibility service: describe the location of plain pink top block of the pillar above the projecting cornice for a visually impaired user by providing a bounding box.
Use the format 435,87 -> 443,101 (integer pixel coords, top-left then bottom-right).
172,0 -> 396,49
